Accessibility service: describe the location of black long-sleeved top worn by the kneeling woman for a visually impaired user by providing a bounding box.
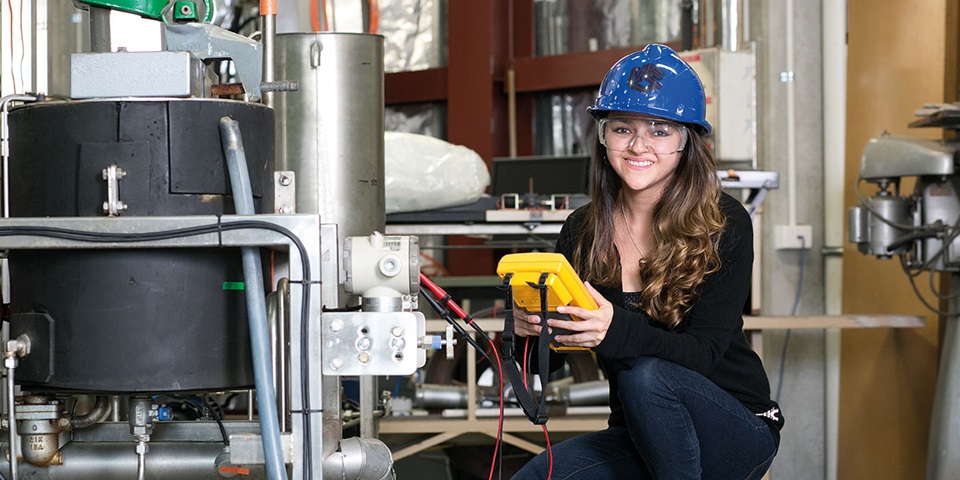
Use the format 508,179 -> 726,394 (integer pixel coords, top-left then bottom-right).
533,193 -> 783,445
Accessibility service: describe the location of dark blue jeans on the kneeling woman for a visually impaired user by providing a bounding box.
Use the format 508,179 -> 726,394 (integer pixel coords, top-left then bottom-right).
513,357 -> 777,480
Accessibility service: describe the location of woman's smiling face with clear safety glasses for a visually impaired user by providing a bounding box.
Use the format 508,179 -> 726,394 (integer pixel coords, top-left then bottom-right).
598,112 -> 687,201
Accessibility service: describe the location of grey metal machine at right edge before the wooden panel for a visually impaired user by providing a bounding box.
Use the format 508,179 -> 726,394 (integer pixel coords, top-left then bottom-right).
848,104 -> 960,480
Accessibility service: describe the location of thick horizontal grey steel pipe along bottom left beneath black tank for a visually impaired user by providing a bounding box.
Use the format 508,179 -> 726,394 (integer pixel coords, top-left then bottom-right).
2,441 -> 266,480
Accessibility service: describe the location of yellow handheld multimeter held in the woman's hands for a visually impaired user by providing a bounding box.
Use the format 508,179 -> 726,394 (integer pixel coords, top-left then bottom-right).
497,253 -> 599,351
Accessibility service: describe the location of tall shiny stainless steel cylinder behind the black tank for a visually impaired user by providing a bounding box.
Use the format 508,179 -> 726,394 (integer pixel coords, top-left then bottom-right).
275,33 -> 386,242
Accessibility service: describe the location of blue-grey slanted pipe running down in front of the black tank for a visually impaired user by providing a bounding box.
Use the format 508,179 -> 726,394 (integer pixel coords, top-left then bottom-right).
220,116 -> 287,480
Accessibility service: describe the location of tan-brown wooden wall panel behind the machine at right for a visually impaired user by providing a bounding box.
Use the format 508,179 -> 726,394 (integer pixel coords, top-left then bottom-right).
838,0 -> 958,480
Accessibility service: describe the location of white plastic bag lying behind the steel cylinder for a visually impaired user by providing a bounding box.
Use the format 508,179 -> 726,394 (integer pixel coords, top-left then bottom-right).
384,132 -> 490,213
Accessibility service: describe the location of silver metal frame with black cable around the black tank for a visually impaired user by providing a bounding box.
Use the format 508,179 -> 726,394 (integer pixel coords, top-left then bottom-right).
0,214 -> 328,478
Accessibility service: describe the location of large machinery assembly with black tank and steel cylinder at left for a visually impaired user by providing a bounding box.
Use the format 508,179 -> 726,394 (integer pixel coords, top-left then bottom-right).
0,0 -> 432,480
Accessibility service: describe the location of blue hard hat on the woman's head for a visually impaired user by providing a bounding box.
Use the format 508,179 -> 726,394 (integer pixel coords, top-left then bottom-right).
587,43 -> 712,134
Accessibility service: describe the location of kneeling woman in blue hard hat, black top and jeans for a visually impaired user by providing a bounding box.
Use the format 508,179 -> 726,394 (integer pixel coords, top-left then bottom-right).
514,45 -> 783,480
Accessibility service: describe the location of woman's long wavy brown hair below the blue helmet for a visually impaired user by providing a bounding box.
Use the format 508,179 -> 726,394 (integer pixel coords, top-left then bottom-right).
573,128 -> 726,329
